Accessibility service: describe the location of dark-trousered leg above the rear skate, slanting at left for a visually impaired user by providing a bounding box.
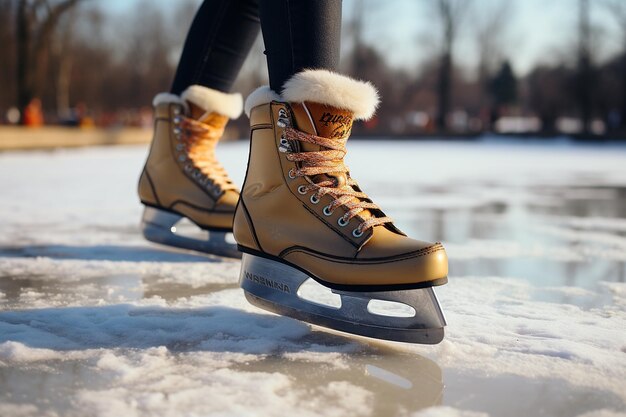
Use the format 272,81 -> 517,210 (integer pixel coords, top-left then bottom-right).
170,0 -> 260,95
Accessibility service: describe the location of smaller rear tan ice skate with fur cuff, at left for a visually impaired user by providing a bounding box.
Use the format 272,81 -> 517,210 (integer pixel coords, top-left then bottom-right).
139,85 -> 243,258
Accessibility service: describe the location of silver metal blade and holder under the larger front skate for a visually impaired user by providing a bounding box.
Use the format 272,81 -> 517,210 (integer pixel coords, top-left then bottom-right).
239,253 -> 446,344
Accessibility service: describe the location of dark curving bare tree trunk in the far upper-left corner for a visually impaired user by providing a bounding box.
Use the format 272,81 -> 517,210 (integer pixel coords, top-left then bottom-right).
16,0 -> 81,122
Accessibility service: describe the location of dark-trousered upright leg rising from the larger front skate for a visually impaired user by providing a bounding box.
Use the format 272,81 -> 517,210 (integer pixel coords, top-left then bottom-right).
259,0 -> 341,92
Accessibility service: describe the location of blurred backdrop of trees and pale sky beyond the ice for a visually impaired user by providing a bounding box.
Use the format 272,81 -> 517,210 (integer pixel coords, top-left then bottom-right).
0,0 -> 626,147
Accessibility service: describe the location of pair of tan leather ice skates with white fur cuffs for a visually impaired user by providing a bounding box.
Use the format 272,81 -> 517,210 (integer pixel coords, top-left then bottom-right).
139,70 -> 448,344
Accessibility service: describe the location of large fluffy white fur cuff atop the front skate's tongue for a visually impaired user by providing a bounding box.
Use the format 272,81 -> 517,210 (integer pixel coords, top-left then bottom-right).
282,70 -> 379,120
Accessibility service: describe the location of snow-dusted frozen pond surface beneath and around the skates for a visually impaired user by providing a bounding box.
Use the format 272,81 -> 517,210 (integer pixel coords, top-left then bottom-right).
0,141 -> 626,417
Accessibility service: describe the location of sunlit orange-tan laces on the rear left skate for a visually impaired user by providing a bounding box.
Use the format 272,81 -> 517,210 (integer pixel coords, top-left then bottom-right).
180,116 -> 237,191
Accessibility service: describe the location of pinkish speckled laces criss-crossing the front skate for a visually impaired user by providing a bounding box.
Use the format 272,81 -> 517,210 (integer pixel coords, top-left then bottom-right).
285,126 -> 393,235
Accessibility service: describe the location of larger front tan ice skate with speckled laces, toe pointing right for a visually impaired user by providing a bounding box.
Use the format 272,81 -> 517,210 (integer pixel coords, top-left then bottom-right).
234,70 -> 448,344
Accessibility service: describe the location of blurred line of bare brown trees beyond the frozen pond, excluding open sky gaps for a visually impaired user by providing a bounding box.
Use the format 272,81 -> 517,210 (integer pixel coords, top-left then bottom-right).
0,0 -> 626,136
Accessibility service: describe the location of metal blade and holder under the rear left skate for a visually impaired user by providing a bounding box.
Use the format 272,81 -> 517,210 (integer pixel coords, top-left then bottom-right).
141,206 -> 241,258
